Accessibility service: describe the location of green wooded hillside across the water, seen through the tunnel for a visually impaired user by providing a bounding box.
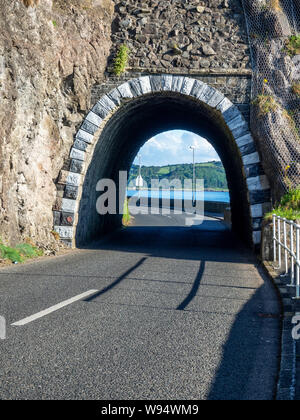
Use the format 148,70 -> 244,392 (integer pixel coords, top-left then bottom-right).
129,162 -> 228,190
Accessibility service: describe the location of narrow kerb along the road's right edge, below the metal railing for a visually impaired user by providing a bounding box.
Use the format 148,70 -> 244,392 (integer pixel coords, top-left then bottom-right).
262,261 -> 297,401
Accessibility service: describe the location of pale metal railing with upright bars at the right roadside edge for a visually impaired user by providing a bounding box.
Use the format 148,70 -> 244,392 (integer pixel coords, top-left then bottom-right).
273,214 -> 300,299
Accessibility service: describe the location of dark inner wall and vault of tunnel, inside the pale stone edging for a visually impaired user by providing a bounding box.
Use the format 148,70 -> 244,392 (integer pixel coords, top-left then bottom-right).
76,92 -> 252,246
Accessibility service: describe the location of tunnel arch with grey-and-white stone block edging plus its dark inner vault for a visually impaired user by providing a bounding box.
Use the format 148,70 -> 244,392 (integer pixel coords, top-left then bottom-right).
54,75 -> 270,246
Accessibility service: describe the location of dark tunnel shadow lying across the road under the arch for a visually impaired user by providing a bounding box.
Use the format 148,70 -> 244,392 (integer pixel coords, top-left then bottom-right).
81,222 -> 257,263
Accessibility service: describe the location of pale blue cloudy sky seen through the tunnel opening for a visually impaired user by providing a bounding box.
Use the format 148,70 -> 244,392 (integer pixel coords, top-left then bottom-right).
134,130 -> 220,166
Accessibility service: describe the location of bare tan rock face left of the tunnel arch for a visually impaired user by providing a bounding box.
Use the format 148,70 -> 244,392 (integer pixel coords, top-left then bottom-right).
0,0 -> 113,243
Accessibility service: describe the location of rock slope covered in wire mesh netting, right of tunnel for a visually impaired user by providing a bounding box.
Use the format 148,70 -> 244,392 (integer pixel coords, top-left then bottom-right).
242,0 -> 300,199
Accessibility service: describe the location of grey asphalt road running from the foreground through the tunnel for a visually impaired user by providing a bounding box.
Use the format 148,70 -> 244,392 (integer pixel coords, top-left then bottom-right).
0,215 -> 280,400
